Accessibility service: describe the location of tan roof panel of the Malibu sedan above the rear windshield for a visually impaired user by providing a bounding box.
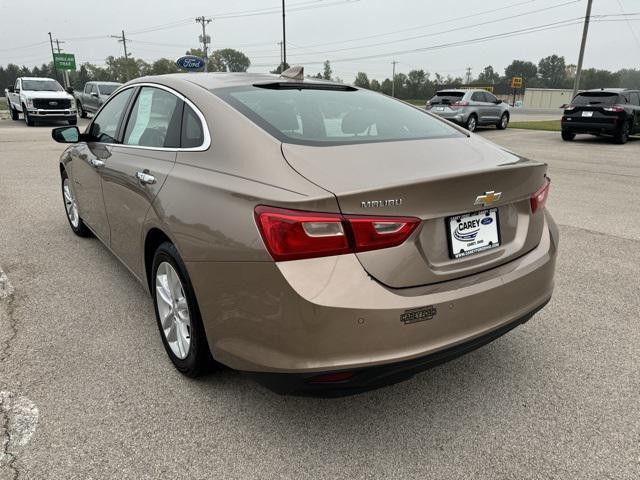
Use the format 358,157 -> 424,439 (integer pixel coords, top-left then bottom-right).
132,72 -> 344,90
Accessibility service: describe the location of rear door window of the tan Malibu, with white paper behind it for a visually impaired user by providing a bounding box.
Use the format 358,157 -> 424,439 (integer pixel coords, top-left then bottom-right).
124,87 -> 182,148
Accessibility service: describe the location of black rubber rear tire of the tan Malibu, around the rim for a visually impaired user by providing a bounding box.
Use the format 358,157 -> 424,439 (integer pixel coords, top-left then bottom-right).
149,242 -> 215,378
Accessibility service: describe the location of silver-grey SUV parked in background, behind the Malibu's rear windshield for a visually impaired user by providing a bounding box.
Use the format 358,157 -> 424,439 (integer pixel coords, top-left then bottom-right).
426,89 -> 510,132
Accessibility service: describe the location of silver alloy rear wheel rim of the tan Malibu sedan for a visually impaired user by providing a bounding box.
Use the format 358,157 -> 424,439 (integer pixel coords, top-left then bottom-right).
156,262 -> 191,360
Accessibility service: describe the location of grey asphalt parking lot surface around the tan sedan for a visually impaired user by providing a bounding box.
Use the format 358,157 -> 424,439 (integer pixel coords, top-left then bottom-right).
0,120 -> 640,480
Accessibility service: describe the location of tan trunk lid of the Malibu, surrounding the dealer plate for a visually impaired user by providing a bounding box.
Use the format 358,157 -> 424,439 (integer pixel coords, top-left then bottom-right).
282,136 -> 546,288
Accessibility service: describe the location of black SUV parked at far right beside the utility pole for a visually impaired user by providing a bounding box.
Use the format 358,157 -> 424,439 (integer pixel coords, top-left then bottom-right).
561,88 -> 640,143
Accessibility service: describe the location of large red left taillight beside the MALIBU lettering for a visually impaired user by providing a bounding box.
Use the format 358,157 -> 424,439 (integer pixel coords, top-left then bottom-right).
255,205 -> 420,261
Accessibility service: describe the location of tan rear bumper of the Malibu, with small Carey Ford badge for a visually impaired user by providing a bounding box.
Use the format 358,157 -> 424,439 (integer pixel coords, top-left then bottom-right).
187,213 -> 558,377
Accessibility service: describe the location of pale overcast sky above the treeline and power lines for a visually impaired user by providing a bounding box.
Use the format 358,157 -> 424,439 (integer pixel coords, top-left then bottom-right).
0,0 -> 640,82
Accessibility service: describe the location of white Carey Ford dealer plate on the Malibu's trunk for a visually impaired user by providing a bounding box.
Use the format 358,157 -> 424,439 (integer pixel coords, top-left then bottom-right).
446,208 -> 501,259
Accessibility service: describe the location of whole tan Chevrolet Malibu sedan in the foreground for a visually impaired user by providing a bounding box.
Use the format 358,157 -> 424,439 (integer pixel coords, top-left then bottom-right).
52,72 -> 558,394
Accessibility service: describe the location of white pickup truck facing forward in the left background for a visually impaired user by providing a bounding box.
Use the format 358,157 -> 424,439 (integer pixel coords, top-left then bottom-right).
5,77 -> 78,127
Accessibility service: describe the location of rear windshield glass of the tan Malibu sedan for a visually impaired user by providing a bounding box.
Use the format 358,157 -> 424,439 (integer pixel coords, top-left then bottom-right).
214,86 -> 464,146
